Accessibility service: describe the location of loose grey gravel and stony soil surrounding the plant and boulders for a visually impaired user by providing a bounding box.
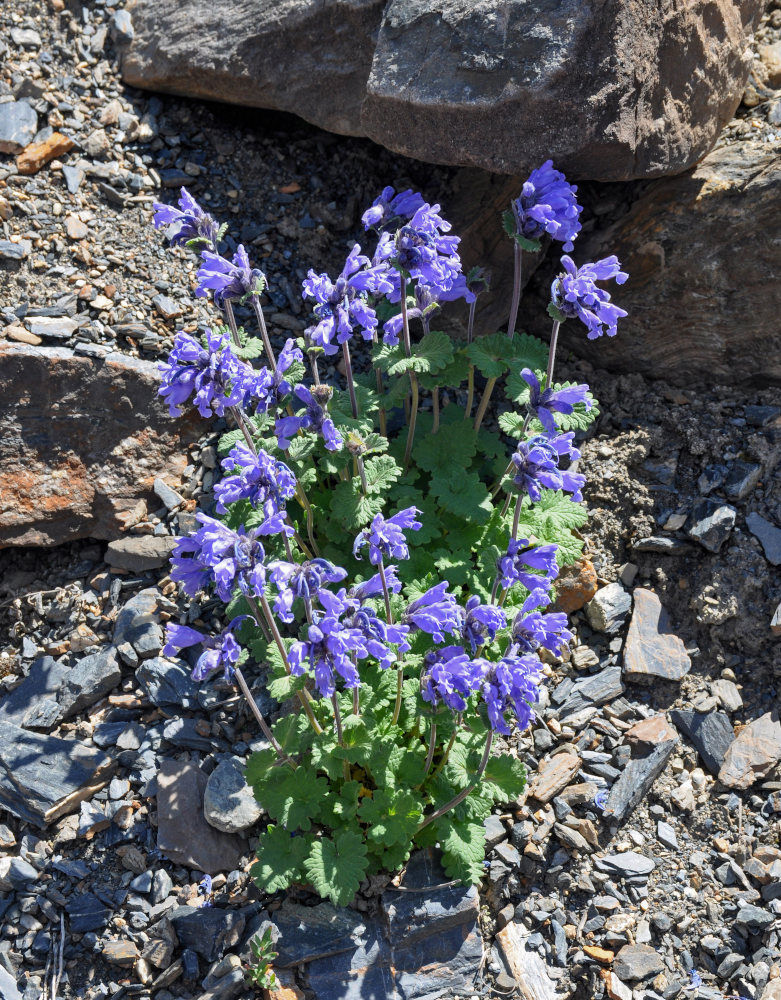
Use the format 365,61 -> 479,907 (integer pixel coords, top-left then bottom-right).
0,0 -> 781,1000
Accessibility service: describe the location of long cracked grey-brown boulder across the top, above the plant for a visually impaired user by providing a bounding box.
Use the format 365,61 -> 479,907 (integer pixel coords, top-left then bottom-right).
123,0 -> 764,180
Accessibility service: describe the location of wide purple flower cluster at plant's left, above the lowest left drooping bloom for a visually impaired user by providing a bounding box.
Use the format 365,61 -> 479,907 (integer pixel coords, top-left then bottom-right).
171,511 -> 293,603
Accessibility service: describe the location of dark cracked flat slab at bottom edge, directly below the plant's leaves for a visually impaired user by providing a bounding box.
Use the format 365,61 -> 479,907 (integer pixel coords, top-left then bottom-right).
274,851 -> 483,1000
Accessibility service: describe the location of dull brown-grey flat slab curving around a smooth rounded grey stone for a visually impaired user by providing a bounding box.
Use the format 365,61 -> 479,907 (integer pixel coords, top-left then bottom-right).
157,760 -> 247,875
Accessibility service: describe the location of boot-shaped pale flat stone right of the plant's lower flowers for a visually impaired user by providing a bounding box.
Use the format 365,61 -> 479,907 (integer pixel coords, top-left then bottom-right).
624,587 -> 691,681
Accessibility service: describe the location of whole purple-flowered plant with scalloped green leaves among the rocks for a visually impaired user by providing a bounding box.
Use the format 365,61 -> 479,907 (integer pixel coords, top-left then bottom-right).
155,162 -> 626,905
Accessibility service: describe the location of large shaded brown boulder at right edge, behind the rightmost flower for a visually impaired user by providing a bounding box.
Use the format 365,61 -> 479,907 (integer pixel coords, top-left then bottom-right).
544,141 -> 781,385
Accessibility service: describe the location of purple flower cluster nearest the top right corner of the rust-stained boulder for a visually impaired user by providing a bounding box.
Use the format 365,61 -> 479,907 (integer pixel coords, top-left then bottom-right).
157,330 -> 258,417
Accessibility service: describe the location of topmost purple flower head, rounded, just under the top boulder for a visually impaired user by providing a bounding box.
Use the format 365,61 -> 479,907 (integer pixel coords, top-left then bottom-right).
513,160 -> 583,251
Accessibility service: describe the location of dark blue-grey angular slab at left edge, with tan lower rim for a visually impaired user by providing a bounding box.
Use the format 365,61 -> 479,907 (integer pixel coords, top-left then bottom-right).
0,721 -> 114,827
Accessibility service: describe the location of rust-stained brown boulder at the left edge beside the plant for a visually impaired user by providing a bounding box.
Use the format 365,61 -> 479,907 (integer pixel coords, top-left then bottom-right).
0,341 -> 199,548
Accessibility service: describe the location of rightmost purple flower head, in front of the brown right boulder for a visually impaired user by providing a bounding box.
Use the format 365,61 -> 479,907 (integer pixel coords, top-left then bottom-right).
551,255 -> 629,340
